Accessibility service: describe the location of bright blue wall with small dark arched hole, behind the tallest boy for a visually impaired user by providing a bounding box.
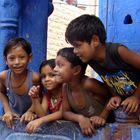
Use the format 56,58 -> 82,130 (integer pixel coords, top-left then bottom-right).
99,0 -> 140,53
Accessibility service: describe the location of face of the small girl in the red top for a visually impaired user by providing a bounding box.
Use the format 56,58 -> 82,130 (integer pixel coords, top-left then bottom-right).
41,65 -> 58,90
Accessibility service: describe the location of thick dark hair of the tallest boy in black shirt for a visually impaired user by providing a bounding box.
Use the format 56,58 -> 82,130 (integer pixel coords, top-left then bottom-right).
65,14 -> 106,45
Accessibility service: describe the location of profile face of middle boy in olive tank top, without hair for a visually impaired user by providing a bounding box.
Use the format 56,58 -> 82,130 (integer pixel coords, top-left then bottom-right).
54,55 -> 74,83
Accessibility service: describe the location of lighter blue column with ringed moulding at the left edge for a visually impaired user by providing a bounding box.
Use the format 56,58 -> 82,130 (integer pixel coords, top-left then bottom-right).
0,0 -> 20,70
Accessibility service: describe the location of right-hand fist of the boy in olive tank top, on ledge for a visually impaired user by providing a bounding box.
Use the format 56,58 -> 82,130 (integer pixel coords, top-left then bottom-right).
90,116 -> 106,127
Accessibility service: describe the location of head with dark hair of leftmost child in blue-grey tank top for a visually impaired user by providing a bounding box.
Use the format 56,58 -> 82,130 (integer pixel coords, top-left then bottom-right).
3,38 -> 32,73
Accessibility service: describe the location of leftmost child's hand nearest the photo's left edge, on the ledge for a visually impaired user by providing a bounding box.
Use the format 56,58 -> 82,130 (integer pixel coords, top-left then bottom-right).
2,111 -> 18,128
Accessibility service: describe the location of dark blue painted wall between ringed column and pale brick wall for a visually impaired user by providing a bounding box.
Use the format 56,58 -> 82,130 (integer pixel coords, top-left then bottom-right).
19,0 -> 53,71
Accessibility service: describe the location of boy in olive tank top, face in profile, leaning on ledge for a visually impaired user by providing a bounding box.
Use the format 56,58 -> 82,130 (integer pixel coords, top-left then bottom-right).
54,48 -> 111,135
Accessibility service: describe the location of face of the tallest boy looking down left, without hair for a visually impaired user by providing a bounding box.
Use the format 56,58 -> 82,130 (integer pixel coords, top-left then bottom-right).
74,41 -> 94,63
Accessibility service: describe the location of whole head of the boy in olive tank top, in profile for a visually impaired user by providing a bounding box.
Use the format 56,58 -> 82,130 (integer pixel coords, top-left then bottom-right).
55,47 -> 87,82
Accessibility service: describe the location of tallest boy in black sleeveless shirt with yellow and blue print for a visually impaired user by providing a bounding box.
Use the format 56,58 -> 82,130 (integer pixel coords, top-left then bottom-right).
65,14 -> 140,122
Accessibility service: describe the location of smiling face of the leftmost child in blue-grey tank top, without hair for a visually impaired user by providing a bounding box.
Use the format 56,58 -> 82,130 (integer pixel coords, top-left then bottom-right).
5,46 -> 32,74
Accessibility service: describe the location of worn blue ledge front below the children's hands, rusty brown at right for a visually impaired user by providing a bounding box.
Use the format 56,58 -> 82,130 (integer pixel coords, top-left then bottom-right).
0,120 -> 140,140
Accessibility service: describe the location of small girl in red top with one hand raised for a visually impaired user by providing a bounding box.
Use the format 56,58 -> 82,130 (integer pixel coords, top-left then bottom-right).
26,59 -> 62,133
